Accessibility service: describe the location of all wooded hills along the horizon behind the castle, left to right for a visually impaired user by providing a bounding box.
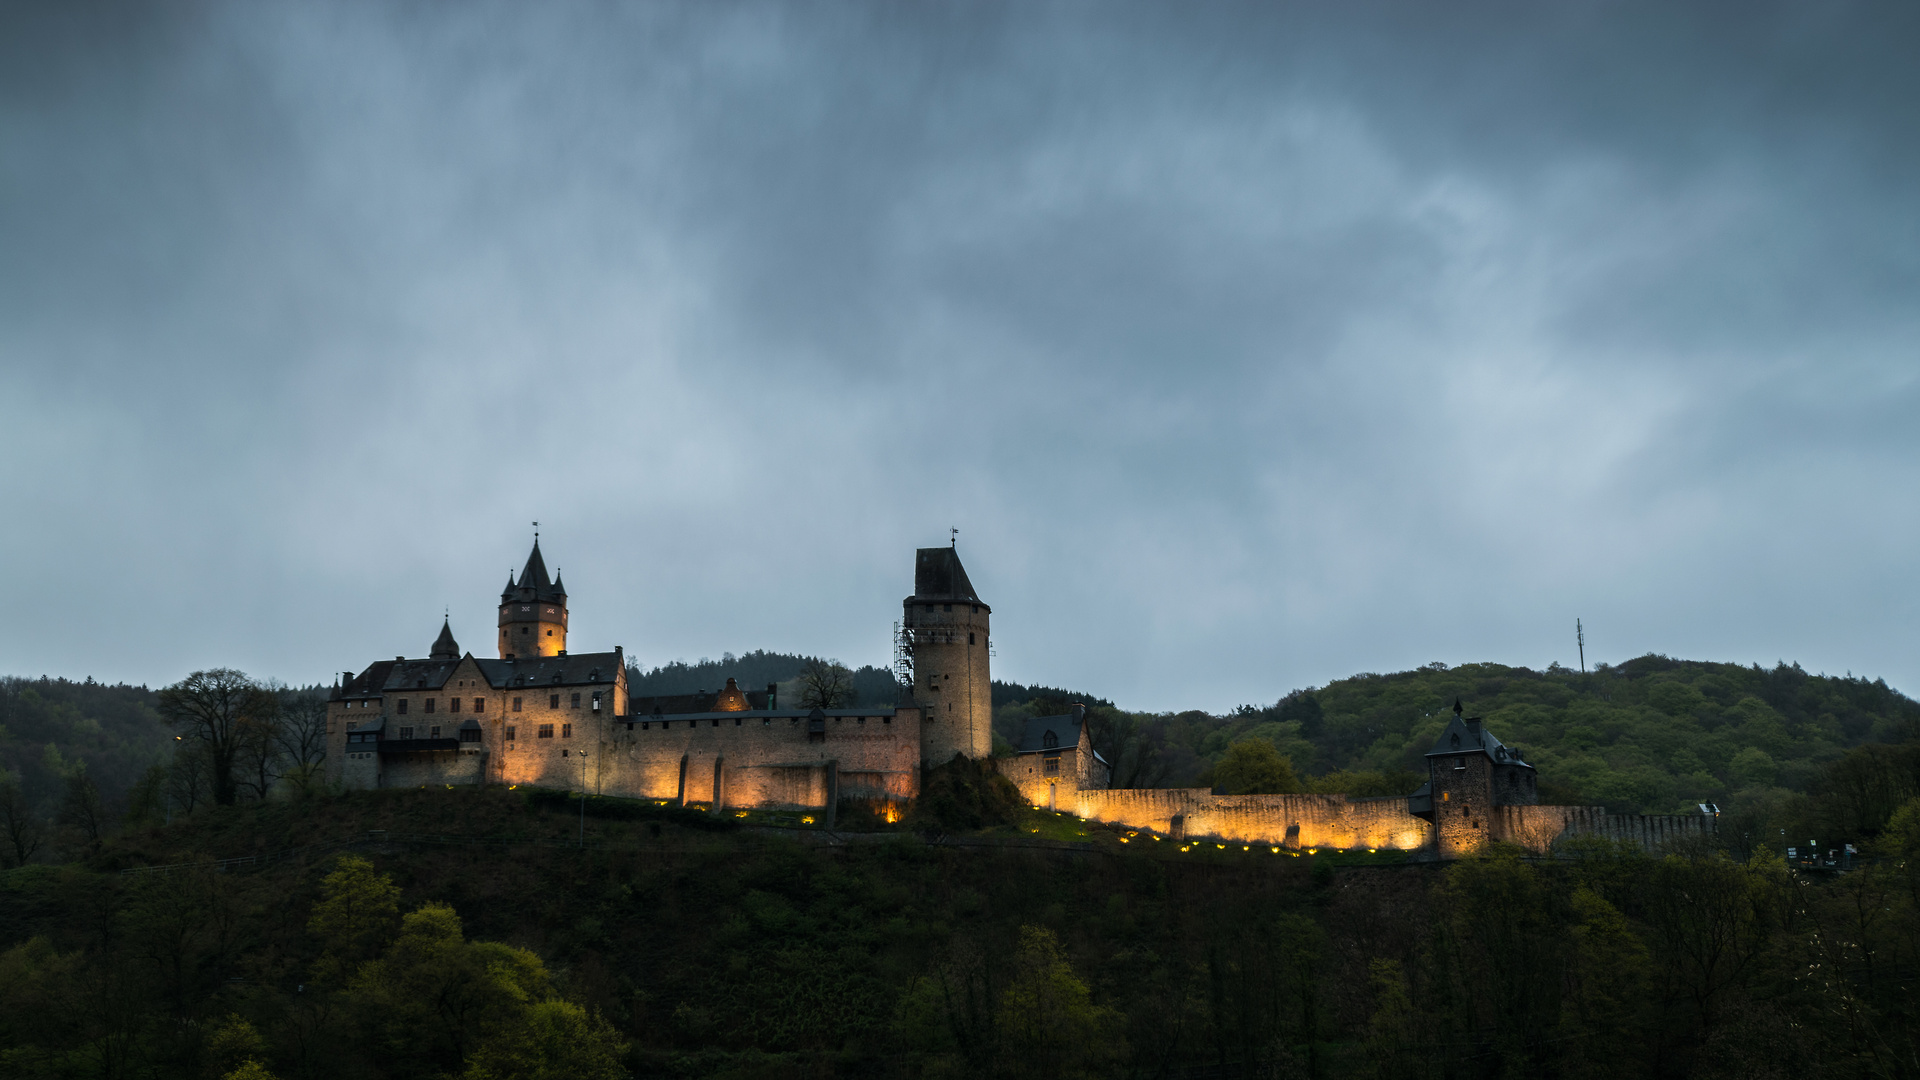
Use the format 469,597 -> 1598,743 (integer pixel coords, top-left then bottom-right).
0,650 -> 1920,813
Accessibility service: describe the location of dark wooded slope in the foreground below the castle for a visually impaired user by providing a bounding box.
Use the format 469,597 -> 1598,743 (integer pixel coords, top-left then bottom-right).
0,788 -> 1920,1080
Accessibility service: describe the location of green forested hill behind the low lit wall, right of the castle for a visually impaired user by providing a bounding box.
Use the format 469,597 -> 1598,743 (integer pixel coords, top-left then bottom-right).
1052,655 -> 1920,813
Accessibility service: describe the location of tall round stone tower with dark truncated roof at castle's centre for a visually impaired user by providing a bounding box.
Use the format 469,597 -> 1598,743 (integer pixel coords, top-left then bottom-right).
900,548 -> 993,765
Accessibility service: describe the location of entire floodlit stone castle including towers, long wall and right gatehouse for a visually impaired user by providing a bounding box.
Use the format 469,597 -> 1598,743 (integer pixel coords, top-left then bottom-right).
326,538 -> 1711,857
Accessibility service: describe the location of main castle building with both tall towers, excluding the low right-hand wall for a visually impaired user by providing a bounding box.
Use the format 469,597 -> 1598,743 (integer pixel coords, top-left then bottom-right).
326,540 -> 993,811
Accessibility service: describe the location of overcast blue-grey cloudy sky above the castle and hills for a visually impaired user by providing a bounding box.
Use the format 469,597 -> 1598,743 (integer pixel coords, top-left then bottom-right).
0,2 -> 1920,711
